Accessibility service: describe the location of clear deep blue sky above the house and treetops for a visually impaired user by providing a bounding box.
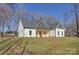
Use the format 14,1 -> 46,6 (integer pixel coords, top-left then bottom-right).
23,3 -> 73,22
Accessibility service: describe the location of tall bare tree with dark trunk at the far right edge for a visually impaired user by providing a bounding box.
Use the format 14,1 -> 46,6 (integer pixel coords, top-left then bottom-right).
65,4 -> 79,37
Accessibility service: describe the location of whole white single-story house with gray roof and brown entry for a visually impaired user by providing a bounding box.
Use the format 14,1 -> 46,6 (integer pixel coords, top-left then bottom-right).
18,20 -> 65,37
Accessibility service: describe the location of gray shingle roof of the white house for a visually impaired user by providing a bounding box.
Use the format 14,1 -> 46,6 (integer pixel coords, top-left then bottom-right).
22,20 -> 63,29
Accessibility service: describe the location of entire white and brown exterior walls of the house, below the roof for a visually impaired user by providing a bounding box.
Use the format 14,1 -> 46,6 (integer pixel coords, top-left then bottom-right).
18,20 -> 65,37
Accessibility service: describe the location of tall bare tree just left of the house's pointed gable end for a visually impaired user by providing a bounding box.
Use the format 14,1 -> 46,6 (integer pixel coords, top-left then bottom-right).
7,3 -> 25,35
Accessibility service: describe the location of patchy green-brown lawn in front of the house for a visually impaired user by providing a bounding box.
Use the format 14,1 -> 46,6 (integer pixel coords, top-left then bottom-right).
0,37 -> 79,55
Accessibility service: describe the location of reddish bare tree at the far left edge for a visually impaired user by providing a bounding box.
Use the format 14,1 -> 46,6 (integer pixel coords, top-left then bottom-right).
0,4 -> 11,39
